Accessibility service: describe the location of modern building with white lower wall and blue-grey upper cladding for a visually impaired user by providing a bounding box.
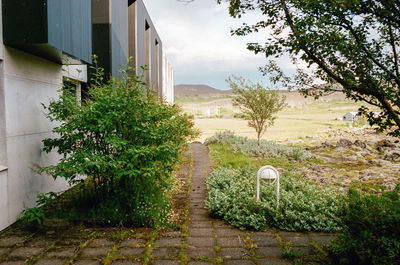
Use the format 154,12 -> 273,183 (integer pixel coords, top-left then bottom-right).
0,0 -> 173,230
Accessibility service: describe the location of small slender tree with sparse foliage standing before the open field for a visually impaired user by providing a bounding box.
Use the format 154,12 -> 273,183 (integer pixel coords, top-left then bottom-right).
226,76 -> 286,145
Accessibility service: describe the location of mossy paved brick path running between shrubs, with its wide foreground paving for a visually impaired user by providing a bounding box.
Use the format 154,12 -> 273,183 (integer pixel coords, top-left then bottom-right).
0,143 -> 333,265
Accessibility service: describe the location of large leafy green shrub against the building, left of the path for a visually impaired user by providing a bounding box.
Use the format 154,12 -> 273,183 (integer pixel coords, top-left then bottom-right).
41,63 -> 195,225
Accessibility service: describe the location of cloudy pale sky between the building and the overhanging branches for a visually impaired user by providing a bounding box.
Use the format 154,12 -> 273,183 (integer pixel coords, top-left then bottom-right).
144,0 -> 292,89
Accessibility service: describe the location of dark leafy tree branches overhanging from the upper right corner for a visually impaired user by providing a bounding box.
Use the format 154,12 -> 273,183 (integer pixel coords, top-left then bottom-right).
217,0 -> 400,135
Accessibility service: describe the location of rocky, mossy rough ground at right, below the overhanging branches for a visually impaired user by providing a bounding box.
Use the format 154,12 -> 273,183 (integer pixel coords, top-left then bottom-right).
292,128 -> 400,193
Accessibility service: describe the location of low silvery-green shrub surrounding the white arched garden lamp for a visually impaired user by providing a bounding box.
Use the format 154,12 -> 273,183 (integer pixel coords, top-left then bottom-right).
206,167 -> 341,231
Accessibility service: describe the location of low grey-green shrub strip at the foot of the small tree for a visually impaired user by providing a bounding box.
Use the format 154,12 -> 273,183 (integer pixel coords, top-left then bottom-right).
205,131 -> 311,160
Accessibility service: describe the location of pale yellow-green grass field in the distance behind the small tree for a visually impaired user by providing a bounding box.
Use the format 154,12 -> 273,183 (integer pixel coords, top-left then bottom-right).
178,95 -> 372,141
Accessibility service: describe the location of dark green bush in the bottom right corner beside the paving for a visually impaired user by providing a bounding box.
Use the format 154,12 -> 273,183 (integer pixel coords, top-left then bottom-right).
331,186 -> 400,264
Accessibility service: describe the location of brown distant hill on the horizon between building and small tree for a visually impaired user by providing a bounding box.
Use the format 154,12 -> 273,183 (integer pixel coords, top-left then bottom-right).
175,84 -> 232,97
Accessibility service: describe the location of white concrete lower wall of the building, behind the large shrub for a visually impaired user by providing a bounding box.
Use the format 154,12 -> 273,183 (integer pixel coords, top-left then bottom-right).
0,47 -> 87,230
